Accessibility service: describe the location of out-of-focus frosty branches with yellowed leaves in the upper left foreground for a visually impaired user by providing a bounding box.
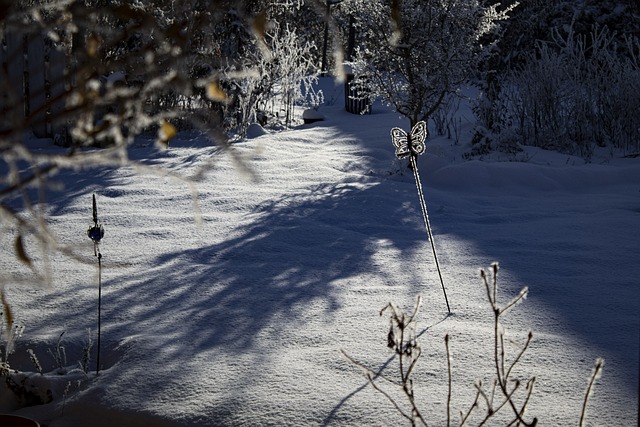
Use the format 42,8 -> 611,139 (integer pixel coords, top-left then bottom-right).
0,0 -> 255,290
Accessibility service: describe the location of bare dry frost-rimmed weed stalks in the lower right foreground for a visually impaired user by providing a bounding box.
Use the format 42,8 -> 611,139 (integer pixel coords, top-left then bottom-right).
342,263 -> 604,427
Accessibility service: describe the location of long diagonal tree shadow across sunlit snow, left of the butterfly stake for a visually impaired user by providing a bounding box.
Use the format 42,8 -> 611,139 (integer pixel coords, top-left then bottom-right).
21,166 -> 425,410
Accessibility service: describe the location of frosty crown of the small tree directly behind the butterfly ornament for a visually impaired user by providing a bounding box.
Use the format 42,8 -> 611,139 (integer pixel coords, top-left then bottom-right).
342,0 -> 509,125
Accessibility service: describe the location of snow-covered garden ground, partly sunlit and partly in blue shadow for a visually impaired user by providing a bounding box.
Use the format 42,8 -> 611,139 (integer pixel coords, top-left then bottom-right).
0,81 -> 640,427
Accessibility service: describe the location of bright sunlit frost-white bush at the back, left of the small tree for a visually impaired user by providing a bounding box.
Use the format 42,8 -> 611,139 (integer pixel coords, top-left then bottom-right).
221,1 -> 322,135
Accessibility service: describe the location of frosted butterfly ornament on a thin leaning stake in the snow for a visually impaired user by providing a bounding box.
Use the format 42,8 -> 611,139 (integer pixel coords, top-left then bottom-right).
391,121 -> 451,314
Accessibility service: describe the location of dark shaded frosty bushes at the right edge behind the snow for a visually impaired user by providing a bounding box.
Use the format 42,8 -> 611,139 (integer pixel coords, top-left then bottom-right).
475,22 -> 640,159
